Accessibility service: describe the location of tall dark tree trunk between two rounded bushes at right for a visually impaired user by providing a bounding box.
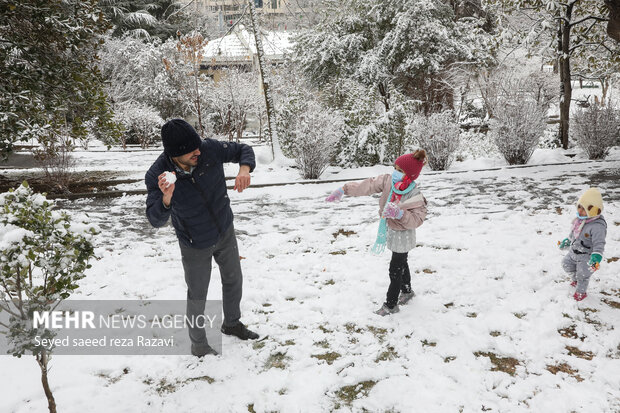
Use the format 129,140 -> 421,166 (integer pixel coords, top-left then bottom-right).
558,3 -> 574,149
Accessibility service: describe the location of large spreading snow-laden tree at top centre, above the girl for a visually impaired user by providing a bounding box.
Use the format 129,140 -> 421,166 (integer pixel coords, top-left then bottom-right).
296,0 -> 495,112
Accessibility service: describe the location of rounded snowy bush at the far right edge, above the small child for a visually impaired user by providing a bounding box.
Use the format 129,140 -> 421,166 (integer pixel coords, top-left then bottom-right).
572,104 -> 620,159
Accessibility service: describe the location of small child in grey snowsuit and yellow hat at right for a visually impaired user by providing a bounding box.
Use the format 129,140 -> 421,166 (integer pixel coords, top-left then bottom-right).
559,188 -> 607,301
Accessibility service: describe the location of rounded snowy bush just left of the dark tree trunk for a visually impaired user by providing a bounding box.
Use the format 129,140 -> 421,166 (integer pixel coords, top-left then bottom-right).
491,101 -> 547,165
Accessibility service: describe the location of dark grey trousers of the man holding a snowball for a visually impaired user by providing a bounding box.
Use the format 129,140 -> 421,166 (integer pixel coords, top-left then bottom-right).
180,224 -> 243,344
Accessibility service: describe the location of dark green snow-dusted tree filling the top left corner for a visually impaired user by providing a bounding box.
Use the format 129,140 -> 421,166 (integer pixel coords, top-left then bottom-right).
0,0 -> 116,155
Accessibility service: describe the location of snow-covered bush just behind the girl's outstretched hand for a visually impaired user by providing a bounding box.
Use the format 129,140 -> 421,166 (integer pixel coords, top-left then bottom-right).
291,101 -> 344,179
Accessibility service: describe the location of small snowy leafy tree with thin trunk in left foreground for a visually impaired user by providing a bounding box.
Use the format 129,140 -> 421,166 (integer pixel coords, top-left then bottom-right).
0,182 -> 98,412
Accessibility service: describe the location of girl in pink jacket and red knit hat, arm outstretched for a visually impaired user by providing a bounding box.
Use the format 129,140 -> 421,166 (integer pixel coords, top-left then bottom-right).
326,150 -> 427,316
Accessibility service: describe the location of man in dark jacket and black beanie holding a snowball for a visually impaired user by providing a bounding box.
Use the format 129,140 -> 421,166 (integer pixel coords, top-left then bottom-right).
145,119 -> 258,357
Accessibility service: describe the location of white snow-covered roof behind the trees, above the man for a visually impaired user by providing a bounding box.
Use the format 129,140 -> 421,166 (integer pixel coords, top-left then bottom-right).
203,27 -> 293,64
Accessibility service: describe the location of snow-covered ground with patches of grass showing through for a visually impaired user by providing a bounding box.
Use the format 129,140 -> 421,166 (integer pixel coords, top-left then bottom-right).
0,149 -> 620,412
